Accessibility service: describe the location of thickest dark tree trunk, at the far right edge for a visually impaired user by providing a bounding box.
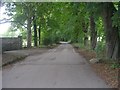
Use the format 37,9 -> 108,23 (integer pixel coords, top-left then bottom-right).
102,2 -> 120,59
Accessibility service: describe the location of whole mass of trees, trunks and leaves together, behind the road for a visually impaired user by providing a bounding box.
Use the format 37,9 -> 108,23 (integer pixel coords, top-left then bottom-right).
1,2 -> 120,60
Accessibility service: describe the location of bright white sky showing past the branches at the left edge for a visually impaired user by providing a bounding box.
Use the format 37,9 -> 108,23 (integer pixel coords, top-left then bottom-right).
0,7 -> 11,35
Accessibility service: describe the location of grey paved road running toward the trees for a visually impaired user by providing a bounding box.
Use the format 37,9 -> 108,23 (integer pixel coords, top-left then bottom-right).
2,44 -> 108,88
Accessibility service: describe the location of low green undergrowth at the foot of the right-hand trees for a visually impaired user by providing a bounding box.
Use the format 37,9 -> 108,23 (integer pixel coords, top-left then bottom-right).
73,43 -> 120,69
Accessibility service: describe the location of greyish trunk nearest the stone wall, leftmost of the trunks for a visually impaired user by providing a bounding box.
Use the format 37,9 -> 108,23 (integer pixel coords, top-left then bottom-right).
27,17 -> 31,48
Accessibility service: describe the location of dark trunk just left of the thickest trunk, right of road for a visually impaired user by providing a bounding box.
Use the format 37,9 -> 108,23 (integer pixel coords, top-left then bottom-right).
90,15 -> 97,50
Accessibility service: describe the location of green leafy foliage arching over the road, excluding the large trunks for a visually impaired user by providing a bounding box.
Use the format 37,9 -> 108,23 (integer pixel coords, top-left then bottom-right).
2,2 -> 120,57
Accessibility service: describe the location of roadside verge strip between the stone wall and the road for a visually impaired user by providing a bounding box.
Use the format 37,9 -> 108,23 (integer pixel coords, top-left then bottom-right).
1,44 -> 59,67
